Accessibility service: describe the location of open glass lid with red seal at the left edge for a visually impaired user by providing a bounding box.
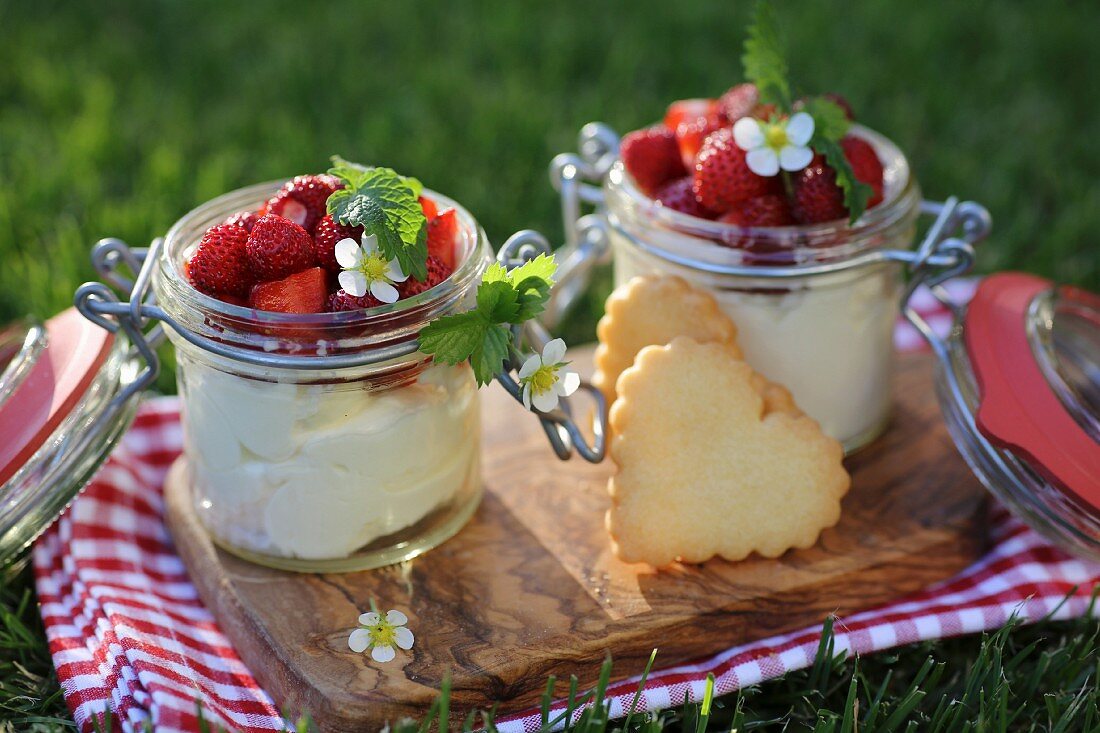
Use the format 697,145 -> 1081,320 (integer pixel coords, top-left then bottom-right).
0,308 -> 138,569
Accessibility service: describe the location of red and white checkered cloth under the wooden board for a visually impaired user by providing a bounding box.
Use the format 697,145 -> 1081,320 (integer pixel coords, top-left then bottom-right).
34,280 -> 1100,733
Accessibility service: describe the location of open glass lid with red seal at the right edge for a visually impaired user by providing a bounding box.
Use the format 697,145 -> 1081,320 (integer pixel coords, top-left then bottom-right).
925,273 -> 1100,560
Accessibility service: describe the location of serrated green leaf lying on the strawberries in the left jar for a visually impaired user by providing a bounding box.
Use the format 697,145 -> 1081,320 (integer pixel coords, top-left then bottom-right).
327,155 -> 428,281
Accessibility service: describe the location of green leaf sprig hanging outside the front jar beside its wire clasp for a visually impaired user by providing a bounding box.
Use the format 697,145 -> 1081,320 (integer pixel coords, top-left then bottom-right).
420,254 -> 558,385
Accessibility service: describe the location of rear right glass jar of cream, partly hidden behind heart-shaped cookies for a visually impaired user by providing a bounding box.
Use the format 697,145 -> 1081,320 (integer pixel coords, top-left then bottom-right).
604,125 -> 921,453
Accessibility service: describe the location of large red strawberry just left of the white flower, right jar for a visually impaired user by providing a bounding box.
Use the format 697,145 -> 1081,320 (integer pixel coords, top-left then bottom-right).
694,128 -> 782,214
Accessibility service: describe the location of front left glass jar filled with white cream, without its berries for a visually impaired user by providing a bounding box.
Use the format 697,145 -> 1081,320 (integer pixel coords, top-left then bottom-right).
153,182 -> 491,572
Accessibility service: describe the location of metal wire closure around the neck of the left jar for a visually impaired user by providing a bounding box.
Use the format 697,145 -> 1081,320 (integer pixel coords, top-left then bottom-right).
74,230 -> 607,463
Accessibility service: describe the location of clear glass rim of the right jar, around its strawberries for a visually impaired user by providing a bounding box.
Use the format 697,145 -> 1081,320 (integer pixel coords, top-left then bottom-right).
605,124 -> 921,266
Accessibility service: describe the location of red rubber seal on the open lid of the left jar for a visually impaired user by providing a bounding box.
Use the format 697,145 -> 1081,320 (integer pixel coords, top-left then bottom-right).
0,308 -> 114,484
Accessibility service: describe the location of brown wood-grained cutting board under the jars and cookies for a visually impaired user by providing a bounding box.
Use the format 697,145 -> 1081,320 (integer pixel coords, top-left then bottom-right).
165,350 -> 985,731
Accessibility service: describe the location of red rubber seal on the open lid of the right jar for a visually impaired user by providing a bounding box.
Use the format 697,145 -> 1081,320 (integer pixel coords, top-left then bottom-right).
964,272 -> 1100,511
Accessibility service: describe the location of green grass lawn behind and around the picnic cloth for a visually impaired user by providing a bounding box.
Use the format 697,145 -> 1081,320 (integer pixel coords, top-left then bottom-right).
0,0 -> 1100,731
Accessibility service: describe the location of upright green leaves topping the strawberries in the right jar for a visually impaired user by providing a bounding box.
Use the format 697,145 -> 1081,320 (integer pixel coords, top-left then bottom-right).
741,0 -> 872,223
